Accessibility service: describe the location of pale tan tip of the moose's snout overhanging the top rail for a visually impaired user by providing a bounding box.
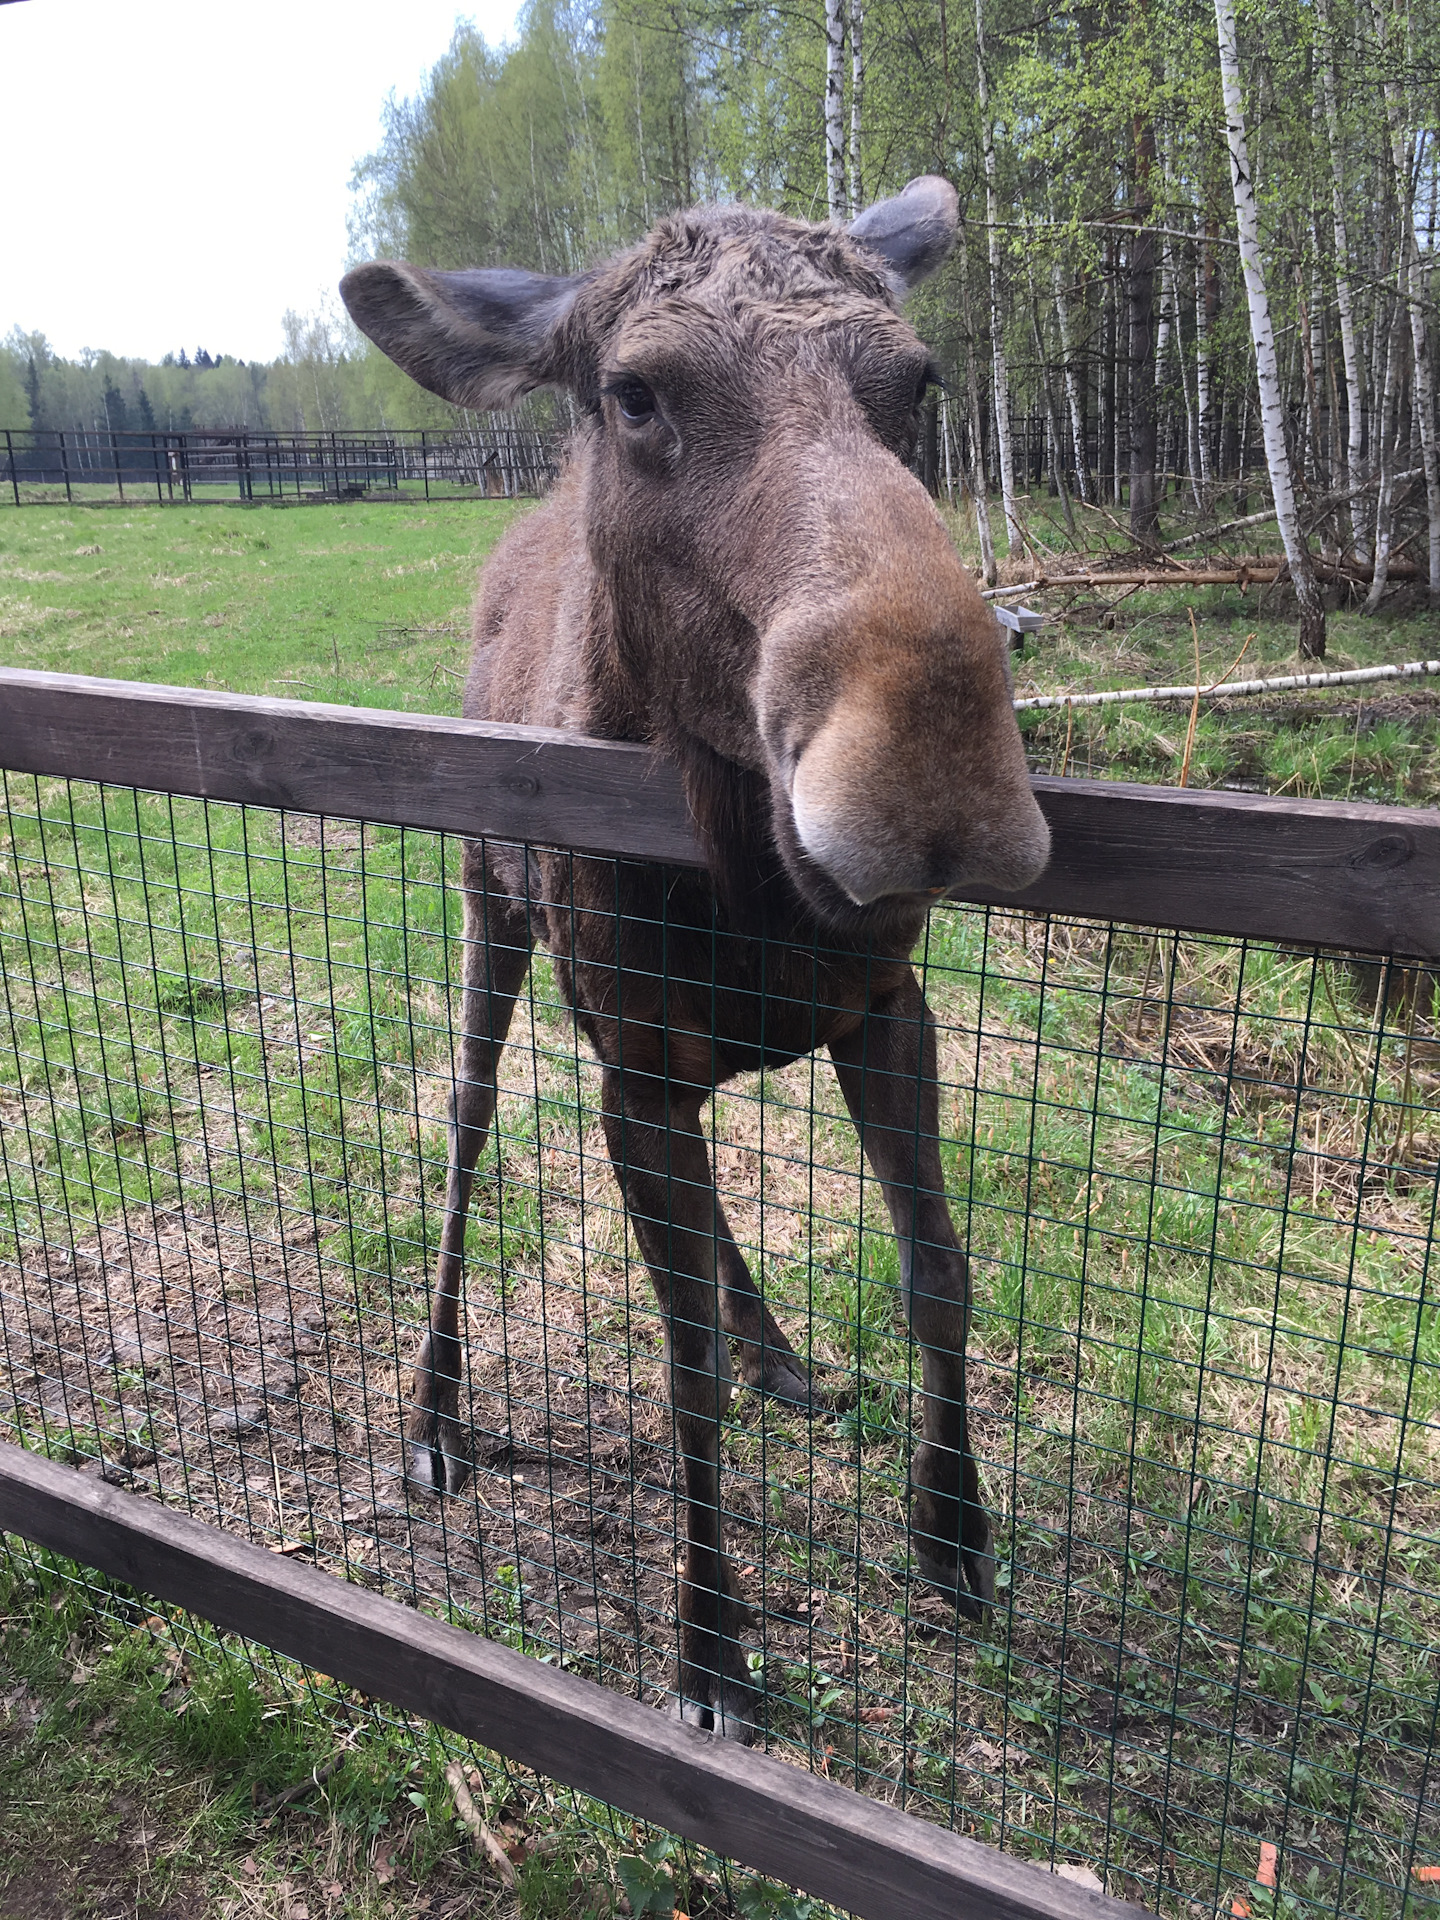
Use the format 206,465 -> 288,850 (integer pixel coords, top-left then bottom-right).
789,705 -> 1050,906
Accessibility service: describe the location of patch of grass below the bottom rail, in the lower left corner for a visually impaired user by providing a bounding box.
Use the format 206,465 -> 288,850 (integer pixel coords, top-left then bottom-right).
0,1549 -> 820,1920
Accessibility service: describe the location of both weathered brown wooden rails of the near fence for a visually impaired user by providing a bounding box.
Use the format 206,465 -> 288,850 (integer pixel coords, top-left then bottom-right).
0,670 -> 1440,1920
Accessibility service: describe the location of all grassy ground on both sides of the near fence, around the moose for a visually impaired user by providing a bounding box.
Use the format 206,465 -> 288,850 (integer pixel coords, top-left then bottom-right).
0,505 -> 1440,1920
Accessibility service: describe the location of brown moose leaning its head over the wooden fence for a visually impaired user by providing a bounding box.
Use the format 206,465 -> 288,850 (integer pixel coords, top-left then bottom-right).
342,175 -> 1048,1741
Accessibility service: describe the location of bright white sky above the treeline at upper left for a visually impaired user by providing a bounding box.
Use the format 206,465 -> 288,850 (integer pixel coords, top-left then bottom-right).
0,0 -> 518,359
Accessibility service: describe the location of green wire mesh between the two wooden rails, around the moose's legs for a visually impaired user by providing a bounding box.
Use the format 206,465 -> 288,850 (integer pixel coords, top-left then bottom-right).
0,774 -> 1440,1916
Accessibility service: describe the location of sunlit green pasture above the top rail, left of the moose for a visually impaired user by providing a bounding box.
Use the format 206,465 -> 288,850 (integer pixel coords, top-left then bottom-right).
0,501 -> 530,712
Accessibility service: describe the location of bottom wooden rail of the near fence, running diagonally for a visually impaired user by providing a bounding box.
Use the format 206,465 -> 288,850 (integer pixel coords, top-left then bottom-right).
0,1444 -> 1125,1920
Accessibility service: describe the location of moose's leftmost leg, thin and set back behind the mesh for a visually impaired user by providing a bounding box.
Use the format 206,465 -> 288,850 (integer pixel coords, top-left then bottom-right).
405,841 -> 536,1494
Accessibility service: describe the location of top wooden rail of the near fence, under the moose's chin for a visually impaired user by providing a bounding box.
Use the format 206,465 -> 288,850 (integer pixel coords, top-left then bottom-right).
0,668 -> 1440,960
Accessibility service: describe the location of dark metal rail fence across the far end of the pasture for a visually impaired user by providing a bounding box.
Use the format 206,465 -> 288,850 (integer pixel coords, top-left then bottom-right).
0,420 -> 563,507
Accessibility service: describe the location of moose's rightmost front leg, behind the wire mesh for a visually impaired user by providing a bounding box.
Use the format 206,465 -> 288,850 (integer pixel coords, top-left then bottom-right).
829,972 -> 995,1620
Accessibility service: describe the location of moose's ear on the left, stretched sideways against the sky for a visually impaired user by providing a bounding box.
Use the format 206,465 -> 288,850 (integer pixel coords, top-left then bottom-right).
340,259 -> 582,407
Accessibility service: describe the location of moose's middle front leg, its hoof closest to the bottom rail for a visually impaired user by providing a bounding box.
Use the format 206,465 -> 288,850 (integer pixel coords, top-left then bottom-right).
603,1048 -> 756,1745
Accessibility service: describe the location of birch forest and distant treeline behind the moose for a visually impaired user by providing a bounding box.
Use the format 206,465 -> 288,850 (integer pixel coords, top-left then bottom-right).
0,0 -> 1440,651
